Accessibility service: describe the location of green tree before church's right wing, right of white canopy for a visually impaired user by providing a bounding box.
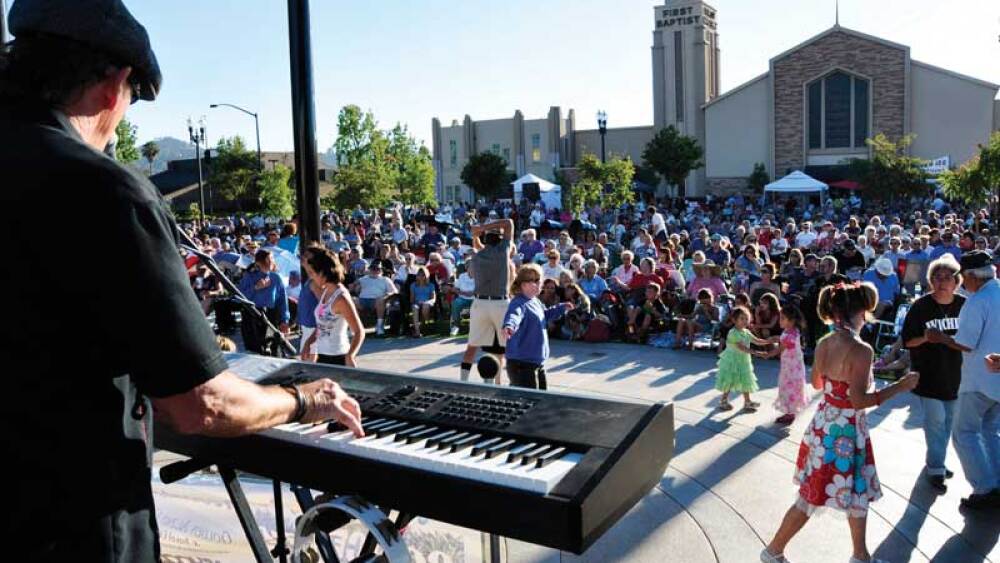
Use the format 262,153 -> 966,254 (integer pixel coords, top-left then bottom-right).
848,133 -> 927,199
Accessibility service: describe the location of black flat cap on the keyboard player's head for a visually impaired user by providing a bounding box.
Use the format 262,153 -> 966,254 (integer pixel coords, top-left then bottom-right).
9,0 -> 163,101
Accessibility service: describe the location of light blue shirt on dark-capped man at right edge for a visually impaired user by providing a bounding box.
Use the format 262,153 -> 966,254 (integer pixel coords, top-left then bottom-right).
954,279 -> 1000,401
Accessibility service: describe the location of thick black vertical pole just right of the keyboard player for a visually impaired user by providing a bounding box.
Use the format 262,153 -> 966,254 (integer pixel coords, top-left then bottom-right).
288,0 -> 320,247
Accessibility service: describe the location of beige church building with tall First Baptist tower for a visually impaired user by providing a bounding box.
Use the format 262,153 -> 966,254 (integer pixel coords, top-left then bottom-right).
432,0 -> 1000,201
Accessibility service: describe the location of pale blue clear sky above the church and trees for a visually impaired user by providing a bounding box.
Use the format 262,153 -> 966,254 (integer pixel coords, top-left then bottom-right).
37,0 -> 1000,151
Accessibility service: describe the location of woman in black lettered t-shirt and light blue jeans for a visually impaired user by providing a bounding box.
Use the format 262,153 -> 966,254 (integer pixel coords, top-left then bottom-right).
902,254 -> 965,491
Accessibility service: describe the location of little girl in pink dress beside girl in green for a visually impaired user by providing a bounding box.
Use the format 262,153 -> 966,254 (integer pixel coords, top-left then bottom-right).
769,305 -> 809,424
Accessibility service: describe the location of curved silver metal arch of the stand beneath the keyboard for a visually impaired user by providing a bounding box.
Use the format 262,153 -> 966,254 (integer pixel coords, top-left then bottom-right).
292,495 -> 410,563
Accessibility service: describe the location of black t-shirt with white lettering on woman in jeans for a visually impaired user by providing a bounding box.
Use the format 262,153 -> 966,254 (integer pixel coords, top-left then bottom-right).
902,294 -> 965,401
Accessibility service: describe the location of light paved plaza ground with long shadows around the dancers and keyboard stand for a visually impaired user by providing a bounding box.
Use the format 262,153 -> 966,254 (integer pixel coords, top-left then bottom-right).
155,338 -> 1000,563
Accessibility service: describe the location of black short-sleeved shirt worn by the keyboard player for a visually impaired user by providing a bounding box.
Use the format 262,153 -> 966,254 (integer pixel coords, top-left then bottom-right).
0,100 -> 226,561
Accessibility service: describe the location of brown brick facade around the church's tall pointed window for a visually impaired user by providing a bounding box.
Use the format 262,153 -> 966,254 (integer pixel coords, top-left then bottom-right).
773,31 -> 906,173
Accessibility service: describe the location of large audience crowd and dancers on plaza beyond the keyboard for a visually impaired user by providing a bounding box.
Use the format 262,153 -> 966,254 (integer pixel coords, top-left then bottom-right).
182,189 -> 1000,561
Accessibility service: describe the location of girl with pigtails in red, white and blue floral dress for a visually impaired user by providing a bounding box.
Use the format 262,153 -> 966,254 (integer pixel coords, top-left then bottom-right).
760,282 -> 920,563
